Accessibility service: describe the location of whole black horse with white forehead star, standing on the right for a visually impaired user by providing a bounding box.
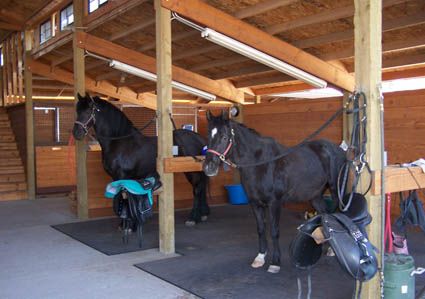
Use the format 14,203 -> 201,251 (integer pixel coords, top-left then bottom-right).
203,111 -> 345,273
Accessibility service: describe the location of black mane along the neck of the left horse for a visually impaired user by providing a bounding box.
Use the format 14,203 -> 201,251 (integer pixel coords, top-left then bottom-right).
93,96 -> 135,136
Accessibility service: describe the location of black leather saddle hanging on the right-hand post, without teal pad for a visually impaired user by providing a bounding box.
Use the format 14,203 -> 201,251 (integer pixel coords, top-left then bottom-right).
289,194 -> 378,281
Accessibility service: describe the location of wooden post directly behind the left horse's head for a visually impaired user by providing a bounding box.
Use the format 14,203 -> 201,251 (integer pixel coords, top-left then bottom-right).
72,0 -> 89,219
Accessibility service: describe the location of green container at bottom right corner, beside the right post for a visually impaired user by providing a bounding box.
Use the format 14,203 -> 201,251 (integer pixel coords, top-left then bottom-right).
384,254 -> 415,299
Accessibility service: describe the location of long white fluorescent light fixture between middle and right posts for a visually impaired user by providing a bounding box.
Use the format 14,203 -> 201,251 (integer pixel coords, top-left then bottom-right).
201,28 -> 327,88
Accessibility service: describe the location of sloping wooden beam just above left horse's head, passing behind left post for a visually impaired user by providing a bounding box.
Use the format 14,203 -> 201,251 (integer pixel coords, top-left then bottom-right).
29,60 -> 156,109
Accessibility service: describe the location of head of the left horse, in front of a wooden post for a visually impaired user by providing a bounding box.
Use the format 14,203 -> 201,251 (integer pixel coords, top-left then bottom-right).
72,94 -> 99,140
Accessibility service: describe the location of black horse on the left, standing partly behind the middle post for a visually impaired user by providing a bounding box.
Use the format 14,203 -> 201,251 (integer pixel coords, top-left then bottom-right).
72,95 -> 210,225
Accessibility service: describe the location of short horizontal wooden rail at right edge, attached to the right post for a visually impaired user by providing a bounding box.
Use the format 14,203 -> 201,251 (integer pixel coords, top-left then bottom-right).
371,165 -> 425,195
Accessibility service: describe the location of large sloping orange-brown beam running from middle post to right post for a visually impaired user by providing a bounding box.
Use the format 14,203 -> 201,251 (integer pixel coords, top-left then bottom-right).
161,0 -> 354,91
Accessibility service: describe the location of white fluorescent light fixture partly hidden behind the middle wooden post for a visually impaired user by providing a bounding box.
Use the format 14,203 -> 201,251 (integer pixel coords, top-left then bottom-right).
109,60 -> 216,101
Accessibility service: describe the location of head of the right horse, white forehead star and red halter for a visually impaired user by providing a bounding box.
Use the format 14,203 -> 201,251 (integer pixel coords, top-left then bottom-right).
203,111 -> 234,176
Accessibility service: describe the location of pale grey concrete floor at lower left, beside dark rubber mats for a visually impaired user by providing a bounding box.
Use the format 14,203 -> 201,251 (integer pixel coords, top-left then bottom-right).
0,198 -> 195,299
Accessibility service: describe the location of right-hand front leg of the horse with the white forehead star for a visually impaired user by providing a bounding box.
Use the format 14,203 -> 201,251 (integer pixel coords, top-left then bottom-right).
267,200 -> 281,273
